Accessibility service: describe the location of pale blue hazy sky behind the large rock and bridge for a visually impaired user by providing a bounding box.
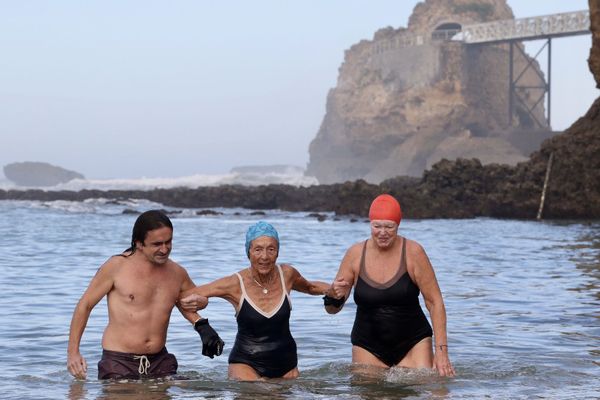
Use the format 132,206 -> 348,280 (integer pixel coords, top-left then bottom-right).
0,0 -> 600,179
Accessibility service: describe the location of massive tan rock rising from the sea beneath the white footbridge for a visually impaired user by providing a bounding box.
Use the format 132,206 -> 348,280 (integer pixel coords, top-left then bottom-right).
307,0 -> 553,183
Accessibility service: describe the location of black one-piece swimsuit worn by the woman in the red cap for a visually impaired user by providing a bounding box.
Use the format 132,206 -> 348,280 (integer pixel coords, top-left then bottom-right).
351,238 -> 433,367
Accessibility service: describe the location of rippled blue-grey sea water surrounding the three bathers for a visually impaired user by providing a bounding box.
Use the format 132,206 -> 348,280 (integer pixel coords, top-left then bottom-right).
0,200 -> 600,399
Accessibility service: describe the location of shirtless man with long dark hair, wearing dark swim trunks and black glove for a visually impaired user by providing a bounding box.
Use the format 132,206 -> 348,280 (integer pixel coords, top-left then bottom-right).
67,210 -> 223,379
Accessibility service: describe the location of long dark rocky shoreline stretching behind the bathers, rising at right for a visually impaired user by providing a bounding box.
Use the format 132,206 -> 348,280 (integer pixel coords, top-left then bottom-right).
0,99 -> 600,219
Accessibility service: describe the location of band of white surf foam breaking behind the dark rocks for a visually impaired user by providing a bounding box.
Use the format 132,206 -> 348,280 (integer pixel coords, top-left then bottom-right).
0,169 -> 319,191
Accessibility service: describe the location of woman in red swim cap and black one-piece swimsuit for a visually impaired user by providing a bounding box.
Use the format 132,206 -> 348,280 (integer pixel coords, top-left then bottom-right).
324,194 -> 454,376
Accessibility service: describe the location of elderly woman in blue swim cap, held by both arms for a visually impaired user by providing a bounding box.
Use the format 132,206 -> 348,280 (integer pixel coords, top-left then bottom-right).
180,221 -> 329,380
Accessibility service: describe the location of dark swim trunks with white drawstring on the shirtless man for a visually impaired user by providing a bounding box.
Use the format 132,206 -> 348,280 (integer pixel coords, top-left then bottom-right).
98,347 -> 177,379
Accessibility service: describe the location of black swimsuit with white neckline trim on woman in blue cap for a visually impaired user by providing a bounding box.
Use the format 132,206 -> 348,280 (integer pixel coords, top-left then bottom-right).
229,266 -> 298,378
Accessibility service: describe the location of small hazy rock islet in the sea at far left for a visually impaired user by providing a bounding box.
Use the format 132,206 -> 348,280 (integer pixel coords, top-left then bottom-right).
4,161 -> 84,186
